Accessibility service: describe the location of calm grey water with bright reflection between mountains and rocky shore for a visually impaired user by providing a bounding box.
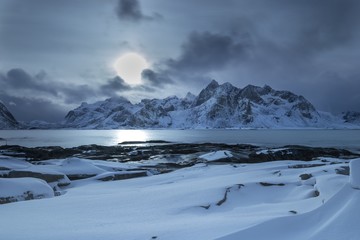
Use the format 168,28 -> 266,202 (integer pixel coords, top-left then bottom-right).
0,129 -> 360,149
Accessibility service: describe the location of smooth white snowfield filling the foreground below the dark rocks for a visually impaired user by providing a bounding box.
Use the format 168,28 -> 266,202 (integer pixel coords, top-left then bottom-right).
0,158 -> 360,240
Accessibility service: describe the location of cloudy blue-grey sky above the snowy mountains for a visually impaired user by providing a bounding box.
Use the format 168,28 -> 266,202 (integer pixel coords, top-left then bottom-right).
0,0 -> 360,122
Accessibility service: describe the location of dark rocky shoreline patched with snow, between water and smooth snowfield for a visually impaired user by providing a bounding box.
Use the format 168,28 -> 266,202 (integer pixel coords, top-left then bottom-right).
0,141 -> 360,204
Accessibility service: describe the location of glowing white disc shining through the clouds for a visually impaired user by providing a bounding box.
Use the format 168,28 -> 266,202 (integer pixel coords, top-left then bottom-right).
114,52 -> 149,85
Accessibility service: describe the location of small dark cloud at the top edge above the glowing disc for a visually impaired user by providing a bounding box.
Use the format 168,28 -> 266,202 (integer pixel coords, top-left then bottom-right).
115,0 -> 162,22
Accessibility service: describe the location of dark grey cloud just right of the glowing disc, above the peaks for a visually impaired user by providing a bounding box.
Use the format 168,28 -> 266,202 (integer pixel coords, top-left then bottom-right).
142,31 -> 252,87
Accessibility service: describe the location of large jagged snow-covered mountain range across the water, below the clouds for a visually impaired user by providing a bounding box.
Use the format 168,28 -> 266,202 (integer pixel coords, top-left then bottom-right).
64,80 -> 356,129
